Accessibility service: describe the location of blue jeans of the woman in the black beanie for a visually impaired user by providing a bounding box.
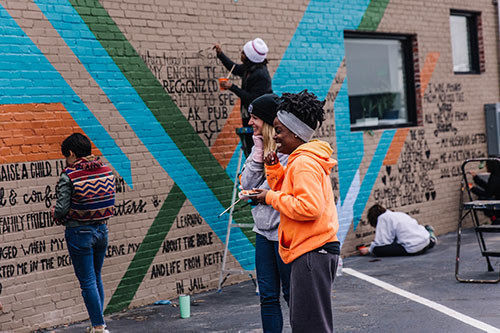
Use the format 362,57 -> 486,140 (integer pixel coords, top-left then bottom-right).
255,234 -> 291,333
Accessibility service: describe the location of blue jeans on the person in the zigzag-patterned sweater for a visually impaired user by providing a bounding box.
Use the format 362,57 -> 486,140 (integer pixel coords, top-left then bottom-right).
65,224 -> 108,326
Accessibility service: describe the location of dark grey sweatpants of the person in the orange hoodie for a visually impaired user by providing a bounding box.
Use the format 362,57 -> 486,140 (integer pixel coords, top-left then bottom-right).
289,250 -> 339,333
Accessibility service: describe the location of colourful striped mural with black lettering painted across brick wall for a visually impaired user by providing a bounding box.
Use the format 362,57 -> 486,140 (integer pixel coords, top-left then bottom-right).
0,0 -> 492,331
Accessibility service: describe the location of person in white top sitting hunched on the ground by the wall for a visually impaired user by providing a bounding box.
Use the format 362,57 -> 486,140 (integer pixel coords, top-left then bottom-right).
359,204 -> 437,257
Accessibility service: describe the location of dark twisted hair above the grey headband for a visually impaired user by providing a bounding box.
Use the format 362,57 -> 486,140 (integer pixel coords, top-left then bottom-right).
278,89 -> 325,130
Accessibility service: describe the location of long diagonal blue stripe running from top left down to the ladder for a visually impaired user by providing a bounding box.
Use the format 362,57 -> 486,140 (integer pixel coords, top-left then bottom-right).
35,0 -> 254,269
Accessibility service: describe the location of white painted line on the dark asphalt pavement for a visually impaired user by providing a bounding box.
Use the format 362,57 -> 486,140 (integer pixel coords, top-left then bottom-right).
342,267 -> 500,333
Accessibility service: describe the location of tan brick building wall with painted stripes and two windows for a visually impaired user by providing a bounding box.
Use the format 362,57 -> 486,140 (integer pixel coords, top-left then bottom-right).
0,0 -> 500,332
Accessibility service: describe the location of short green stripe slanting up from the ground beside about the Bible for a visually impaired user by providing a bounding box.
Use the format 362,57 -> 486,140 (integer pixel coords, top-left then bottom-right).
104,184 -> 186,314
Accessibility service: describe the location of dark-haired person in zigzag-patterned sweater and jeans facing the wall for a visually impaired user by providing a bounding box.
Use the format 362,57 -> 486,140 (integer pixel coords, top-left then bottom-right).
52,133 -> 115,333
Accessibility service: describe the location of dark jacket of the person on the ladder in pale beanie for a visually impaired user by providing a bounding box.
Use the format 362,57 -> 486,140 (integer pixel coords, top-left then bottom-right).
217,52 -> 273,118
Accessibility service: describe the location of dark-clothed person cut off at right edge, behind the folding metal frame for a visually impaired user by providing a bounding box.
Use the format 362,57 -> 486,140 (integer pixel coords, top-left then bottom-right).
469,160 -> 500,224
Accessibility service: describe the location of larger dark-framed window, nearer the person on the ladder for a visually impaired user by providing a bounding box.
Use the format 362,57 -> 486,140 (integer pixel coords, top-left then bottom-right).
344,31 -> 417,130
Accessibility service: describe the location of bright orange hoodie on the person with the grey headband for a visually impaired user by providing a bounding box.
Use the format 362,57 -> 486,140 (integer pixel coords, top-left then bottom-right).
266,140 -> 339,264
